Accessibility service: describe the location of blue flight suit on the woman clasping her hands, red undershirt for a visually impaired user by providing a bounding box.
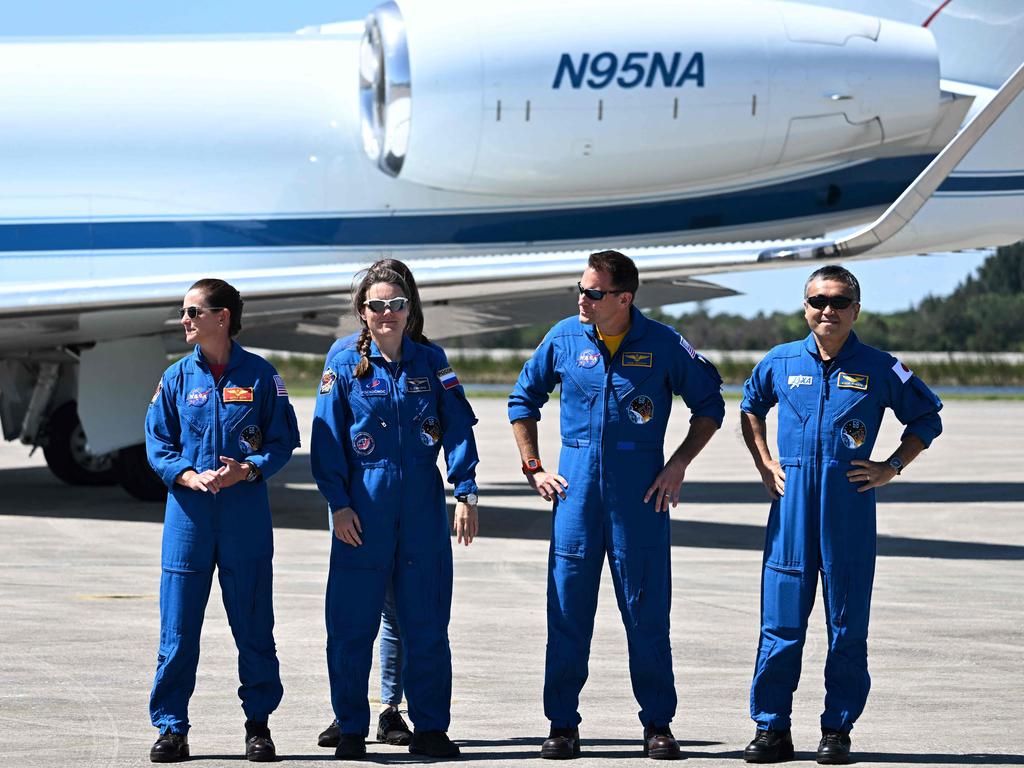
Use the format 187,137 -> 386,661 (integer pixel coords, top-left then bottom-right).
145,342 -> 299,733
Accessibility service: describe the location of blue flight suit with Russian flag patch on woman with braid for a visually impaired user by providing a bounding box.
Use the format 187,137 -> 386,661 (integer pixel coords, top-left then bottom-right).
310,337 -> 478,736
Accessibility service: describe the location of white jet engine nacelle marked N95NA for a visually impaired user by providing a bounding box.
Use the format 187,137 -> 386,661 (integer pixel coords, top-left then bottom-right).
360,0 -> 941,195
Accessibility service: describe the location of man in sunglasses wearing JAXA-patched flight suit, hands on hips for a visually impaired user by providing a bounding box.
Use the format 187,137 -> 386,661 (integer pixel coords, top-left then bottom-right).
740,265 -> 942,765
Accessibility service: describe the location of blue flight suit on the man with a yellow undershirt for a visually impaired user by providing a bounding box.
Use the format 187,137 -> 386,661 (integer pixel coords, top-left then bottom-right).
509,307 -> 725,728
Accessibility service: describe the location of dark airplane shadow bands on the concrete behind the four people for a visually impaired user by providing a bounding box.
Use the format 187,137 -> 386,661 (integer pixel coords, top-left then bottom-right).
8,456 -> 1024,560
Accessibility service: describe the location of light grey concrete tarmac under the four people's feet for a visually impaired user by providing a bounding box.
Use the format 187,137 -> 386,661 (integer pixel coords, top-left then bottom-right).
0,398 -> 1024,768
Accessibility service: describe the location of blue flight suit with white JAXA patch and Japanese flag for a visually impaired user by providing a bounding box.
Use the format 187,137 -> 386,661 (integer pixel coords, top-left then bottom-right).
740,332 -> 942,731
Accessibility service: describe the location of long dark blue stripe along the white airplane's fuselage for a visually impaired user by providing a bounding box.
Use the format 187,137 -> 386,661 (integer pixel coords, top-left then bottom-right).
0,156 -> 1024,252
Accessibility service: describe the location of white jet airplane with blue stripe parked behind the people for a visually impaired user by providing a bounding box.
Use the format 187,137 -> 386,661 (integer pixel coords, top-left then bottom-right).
0,0 -> 1024,497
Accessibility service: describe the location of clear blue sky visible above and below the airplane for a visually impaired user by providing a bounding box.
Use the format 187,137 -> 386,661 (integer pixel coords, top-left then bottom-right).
0,0 -> 984,315
